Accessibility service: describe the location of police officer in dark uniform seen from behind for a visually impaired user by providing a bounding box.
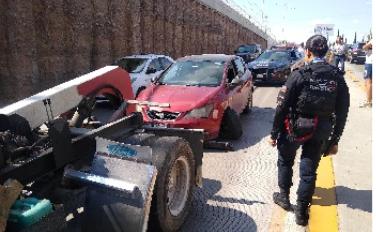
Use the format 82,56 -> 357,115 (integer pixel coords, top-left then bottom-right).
269,35 -> 349,226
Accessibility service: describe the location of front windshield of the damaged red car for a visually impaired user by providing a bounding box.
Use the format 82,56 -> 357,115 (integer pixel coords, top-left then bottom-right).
158,60 -> 225,86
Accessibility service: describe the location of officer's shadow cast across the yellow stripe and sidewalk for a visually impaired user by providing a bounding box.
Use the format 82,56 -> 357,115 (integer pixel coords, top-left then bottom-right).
312,186 -> 372,213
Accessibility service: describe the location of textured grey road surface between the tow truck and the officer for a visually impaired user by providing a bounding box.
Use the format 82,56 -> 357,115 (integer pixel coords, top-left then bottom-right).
182,87 -> 294,232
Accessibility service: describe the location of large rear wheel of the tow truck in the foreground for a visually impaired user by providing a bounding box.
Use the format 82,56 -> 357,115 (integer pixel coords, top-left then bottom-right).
149,137 -> 195,232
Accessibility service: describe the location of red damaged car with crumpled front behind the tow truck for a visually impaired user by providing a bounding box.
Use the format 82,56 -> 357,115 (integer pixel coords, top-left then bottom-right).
137,54 -> 253,140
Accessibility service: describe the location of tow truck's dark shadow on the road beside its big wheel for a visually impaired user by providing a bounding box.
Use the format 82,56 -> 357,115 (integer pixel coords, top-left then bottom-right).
181,178 -> 265,232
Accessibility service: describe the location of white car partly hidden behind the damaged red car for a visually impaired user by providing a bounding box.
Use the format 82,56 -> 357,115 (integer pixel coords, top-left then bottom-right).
115,54 -> 174,97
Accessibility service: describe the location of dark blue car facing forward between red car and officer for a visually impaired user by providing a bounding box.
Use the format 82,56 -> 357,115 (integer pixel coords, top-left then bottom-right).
248,50 -> 301,84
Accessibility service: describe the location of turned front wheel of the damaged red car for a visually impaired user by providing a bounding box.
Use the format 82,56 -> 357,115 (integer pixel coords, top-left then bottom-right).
220,108 -> 243,140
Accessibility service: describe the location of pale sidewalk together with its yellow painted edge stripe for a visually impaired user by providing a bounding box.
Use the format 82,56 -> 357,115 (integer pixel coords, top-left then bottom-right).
308,64 -> 372,232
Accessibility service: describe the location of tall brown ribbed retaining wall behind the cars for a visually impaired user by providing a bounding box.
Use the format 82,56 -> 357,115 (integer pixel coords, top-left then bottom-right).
0,0 -> 267,105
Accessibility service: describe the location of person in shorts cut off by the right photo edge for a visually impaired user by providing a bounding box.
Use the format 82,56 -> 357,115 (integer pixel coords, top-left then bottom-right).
360,39 -> 373,107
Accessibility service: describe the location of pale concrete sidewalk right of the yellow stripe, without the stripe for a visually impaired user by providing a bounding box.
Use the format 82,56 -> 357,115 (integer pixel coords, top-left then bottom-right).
333,62 -> 372,232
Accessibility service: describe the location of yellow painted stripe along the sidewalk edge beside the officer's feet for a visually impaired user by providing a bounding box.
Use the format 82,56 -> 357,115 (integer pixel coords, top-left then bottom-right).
308,156 -> 338,232
